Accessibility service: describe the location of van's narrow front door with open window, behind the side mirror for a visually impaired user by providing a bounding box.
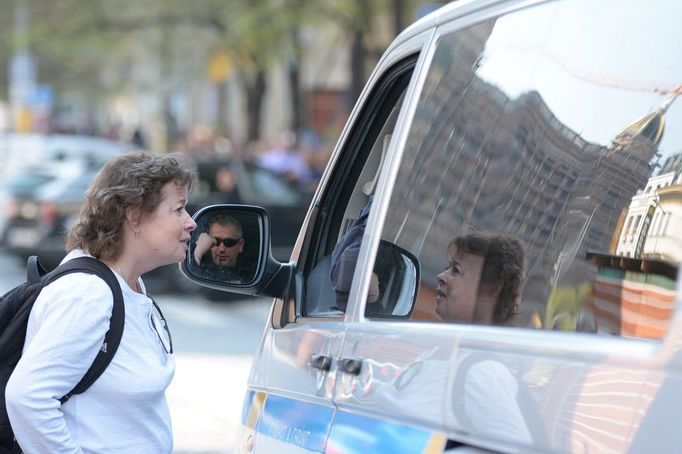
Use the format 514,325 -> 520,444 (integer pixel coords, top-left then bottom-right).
242,30 -> 427,453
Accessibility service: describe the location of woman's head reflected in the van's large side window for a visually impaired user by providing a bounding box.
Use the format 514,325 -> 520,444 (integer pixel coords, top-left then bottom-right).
436,234 -> 524,325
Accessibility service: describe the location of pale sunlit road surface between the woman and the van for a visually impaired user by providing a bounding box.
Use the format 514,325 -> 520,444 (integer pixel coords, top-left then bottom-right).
0,251 -> 271,454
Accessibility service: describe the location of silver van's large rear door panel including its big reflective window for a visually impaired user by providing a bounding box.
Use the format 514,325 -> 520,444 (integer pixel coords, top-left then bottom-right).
328,0 -> 682,452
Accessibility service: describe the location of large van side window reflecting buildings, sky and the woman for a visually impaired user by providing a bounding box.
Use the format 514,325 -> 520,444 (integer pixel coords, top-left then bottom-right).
366,4 -> 682,340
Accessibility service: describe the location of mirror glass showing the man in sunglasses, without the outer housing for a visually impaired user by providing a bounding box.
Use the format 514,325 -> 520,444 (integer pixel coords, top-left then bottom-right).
186,208 -> 263,285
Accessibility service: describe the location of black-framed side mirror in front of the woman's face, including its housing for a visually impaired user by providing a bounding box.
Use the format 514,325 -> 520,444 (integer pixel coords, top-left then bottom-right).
180,205 -> 293,298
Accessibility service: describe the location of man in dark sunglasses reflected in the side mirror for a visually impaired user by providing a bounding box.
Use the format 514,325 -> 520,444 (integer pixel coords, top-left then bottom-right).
192,213 -> 249,284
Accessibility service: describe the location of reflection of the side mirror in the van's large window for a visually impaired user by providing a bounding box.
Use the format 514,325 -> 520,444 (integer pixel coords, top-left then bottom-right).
365,240 -> 420,318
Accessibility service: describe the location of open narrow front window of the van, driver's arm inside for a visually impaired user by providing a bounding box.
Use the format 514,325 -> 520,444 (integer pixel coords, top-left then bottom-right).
301,58 -> 418,317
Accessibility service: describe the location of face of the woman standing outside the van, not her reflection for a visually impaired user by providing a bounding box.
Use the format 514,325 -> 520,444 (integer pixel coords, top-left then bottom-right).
138,181 -> 197,270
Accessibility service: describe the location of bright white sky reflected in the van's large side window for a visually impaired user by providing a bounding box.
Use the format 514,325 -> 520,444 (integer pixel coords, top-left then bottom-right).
477,0 -> 682,158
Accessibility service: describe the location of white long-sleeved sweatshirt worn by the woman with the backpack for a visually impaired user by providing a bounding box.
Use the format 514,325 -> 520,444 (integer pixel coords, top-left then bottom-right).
5,251 -> 175,454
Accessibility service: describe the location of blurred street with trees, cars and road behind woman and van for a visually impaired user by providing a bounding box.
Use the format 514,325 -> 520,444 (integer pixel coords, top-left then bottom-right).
0,0 -> 447,454
